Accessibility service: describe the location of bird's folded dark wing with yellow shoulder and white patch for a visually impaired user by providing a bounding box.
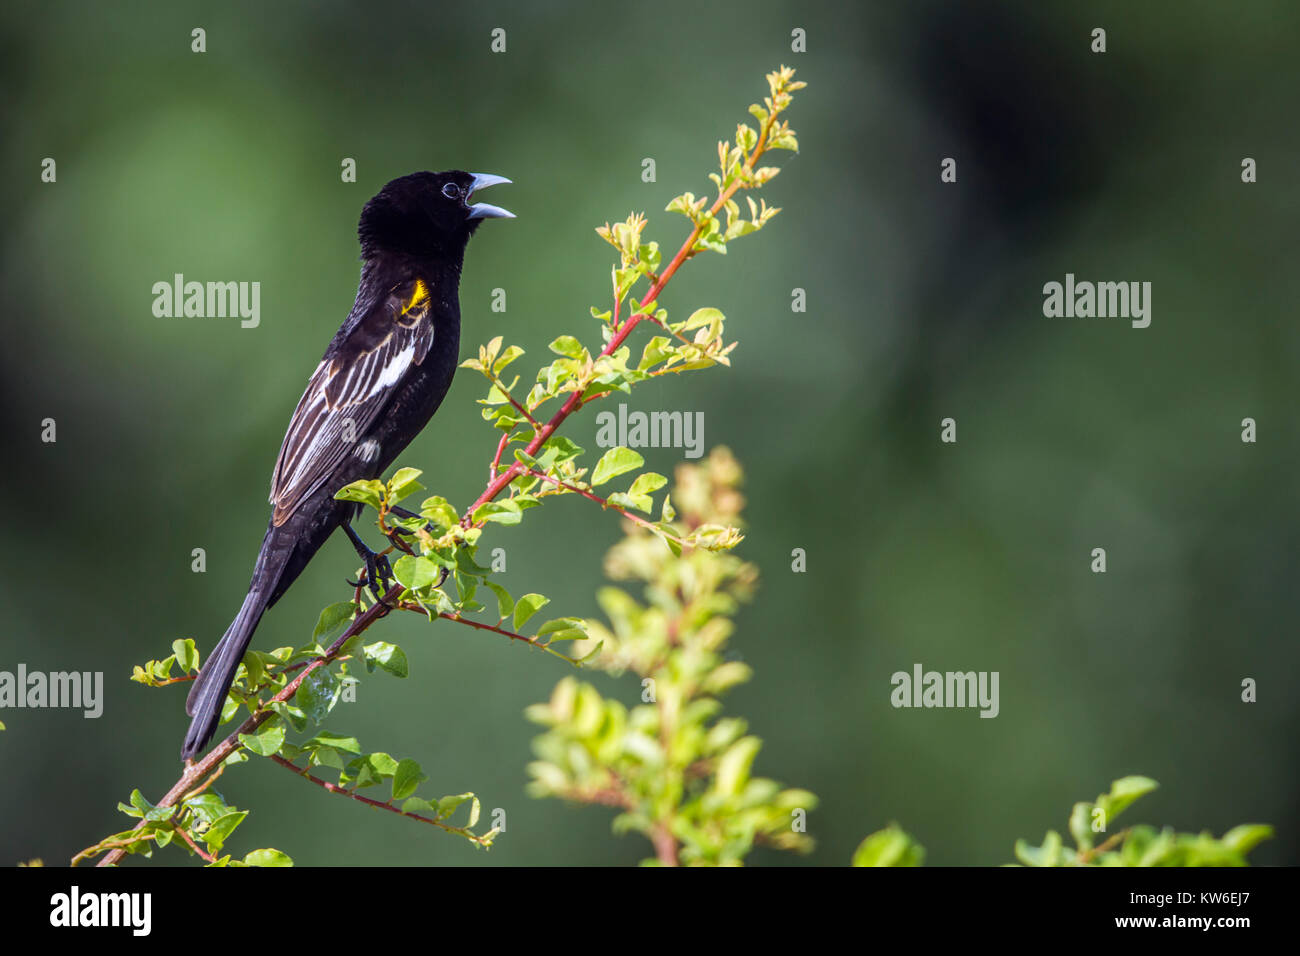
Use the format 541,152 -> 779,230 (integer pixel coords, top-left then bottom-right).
270,280 -> 434,525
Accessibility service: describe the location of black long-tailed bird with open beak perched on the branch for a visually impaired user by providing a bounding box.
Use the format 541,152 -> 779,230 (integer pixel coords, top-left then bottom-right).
181,170 -> 514,760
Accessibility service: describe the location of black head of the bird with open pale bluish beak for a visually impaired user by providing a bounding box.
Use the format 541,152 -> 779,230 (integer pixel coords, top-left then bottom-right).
358,169 -> 515,261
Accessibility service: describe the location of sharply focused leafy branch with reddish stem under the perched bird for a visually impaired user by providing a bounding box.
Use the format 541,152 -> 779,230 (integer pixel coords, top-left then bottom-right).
83,66 -> 803,865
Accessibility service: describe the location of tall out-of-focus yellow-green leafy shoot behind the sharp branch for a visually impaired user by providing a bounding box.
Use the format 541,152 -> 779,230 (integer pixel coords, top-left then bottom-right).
527,449 -> 816,865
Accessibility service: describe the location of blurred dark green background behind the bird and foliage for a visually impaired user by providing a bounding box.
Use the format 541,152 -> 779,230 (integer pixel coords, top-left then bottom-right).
0,1 -> 1300,865
